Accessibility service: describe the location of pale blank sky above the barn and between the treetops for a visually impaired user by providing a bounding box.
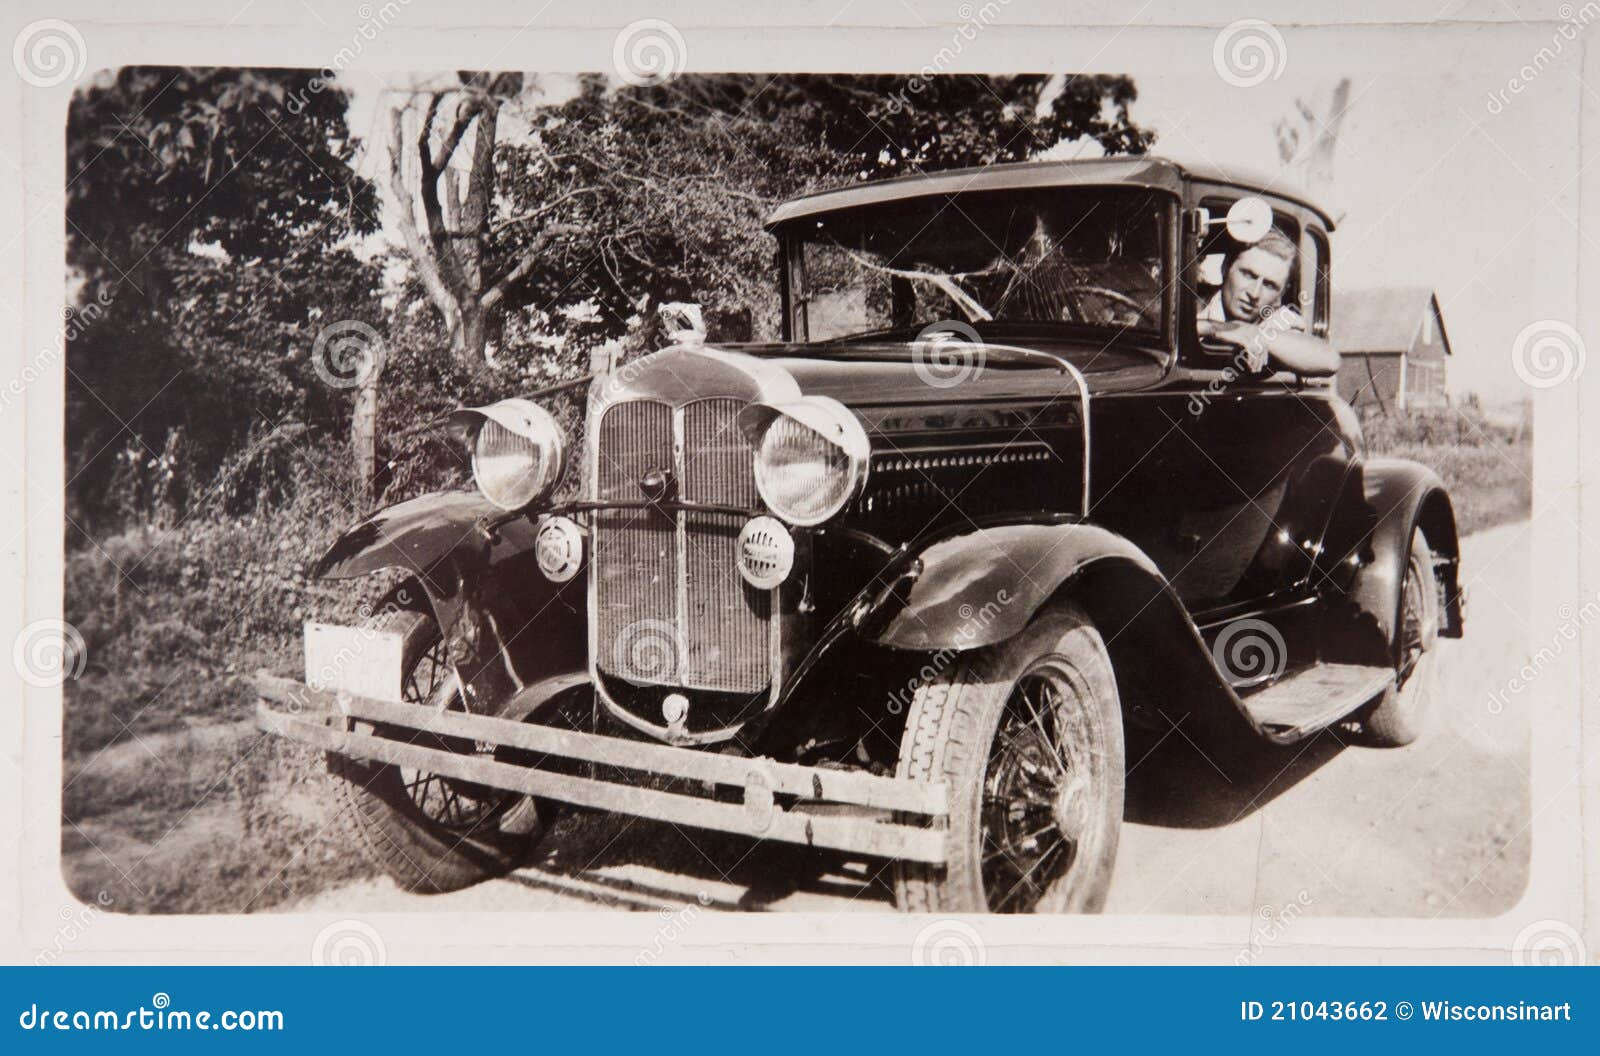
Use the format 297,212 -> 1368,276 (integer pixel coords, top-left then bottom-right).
342,24 -> 1574,402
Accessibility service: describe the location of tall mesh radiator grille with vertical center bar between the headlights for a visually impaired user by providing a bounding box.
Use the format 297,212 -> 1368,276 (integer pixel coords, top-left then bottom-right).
592,400 -> 771,693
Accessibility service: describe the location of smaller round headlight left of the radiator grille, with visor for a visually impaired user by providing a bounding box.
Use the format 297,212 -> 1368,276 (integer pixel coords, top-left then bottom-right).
456,400 -> 566,510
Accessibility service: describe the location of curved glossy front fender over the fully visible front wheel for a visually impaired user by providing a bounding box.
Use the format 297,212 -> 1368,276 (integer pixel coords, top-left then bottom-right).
875,520 -> 1261,747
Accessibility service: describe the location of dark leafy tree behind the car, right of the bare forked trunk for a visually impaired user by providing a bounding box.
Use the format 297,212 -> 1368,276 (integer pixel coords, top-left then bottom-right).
485,75 -> 1152,360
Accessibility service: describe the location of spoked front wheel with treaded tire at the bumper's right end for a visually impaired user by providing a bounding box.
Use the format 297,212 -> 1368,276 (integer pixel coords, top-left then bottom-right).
896,605 -> 1125,914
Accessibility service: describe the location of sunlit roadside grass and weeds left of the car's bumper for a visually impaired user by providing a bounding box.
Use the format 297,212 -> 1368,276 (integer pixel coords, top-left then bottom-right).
61,496 -> 403,912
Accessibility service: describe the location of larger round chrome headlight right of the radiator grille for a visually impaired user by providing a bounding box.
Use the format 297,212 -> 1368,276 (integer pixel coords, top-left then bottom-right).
741,397 -> 870,526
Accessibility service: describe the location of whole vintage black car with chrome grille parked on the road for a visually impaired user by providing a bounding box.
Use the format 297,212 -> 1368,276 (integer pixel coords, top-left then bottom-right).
258,157 -> 1462,912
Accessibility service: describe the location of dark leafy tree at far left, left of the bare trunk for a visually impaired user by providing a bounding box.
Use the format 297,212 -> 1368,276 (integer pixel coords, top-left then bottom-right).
66,67 -> 381,523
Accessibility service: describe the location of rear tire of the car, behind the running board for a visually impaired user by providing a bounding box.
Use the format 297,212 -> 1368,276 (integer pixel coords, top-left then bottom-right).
1362,528 -> 1438,747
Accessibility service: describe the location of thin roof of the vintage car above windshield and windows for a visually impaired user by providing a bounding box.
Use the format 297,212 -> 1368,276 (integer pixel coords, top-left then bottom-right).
766,154 -> 1333,230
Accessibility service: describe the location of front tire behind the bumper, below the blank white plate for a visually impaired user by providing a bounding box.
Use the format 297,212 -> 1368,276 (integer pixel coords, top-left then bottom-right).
328,606 -> 544,894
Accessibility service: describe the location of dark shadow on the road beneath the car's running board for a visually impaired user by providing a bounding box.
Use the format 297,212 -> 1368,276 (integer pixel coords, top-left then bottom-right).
1123,728 -> 1352,829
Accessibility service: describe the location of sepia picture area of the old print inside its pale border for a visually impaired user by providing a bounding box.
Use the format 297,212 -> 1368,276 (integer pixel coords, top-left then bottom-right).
34,3 -> 1574,963
